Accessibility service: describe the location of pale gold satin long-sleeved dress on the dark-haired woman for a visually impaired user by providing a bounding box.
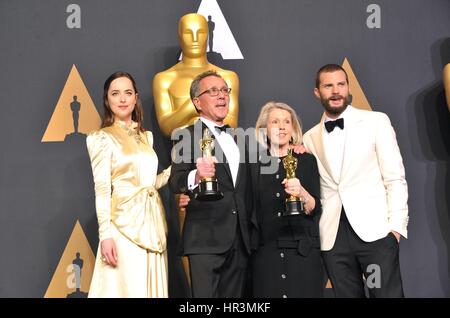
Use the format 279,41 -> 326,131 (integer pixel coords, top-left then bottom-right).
86,121 -> 170,298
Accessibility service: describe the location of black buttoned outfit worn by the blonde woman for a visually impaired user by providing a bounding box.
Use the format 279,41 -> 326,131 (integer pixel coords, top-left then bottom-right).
251,153 -> 324,297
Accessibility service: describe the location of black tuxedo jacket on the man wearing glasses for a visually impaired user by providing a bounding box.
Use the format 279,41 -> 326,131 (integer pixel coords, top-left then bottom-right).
169,120 -> 252,255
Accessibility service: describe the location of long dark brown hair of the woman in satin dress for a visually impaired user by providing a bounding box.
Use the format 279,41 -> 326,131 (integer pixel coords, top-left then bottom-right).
102,72 -> 145,132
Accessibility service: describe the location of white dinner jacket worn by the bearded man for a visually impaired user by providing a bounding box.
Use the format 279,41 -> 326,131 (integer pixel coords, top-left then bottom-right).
303,106 -> 408,251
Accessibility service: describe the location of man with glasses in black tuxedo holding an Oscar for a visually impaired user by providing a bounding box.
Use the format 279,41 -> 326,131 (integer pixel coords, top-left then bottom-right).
169,71 -> 251,297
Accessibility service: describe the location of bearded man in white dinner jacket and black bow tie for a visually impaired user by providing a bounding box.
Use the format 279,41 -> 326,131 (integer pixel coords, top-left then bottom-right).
303,64 -> 408,297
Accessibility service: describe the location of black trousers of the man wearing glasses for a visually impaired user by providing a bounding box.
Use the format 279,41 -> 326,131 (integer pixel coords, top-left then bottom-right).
188,226 -> 248,298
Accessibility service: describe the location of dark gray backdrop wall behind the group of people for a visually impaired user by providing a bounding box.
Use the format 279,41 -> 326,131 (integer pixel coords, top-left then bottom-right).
0,0 -> 450,297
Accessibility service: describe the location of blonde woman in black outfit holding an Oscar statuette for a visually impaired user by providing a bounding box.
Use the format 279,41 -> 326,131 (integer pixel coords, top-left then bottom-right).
250,102 -> 324,298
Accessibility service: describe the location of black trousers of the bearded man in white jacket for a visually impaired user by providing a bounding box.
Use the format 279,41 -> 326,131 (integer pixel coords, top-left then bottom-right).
322,208 -> 404,298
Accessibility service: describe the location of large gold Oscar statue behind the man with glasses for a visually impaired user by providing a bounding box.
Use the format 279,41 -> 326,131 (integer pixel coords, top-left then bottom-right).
153,13 -> 239,136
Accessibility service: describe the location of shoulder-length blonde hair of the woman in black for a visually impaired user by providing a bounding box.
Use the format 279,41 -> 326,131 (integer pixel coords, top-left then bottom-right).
255,102 -> 303,148
